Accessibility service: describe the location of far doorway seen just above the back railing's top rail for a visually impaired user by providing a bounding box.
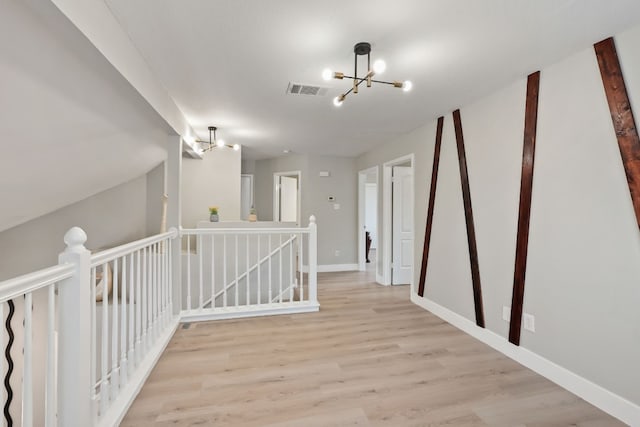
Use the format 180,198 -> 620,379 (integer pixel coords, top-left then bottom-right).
273,171 -> 301,224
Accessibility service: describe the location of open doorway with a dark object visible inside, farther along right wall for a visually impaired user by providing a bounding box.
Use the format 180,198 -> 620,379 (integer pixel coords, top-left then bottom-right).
358,166 -> 381,276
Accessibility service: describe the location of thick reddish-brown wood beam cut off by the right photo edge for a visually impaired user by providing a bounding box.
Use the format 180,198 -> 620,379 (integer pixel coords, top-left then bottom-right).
594,38 -> 640,226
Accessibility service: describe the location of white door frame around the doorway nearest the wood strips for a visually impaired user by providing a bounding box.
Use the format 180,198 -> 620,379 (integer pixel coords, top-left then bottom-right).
378,153 -> 416,289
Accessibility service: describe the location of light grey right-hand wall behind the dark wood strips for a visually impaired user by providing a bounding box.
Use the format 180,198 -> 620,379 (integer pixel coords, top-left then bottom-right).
357,28 -> 640,412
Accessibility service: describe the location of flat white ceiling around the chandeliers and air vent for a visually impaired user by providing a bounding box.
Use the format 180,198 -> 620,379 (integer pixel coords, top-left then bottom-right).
105,0 -> 640,158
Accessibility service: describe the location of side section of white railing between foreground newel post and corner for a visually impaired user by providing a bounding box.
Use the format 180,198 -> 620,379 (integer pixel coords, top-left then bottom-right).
90,229 -> 178,425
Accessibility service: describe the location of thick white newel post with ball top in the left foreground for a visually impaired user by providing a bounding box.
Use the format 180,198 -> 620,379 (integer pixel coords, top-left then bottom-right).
58,227 -> 93,427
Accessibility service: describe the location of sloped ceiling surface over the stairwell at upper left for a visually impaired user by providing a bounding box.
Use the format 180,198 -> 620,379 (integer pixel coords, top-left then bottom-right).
0,0 -> 170,231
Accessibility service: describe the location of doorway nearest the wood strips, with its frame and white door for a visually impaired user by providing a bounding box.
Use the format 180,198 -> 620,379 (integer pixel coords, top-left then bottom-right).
382,154 -> 414,285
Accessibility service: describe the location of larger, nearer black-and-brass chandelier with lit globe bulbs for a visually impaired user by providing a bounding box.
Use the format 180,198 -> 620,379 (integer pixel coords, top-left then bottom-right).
322,42 -> 413,107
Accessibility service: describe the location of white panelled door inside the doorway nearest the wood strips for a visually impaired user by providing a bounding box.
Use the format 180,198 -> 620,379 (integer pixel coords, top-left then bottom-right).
391,166 -> 413,285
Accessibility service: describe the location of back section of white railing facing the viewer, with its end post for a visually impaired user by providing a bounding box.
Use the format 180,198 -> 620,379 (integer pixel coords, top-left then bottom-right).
181,216 -> 319,320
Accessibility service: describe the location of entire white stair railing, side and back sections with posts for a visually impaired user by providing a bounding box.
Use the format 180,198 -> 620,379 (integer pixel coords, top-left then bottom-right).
0,216 -> 319,427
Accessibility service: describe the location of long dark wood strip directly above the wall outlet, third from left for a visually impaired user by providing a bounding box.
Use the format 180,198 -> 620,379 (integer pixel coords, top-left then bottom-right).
509,71 -> 540,345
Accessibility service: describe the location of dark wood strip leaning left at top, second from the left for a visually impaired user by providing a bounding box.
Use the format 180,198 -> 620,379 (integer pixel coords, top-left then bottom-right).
453,110 -> 484,328
